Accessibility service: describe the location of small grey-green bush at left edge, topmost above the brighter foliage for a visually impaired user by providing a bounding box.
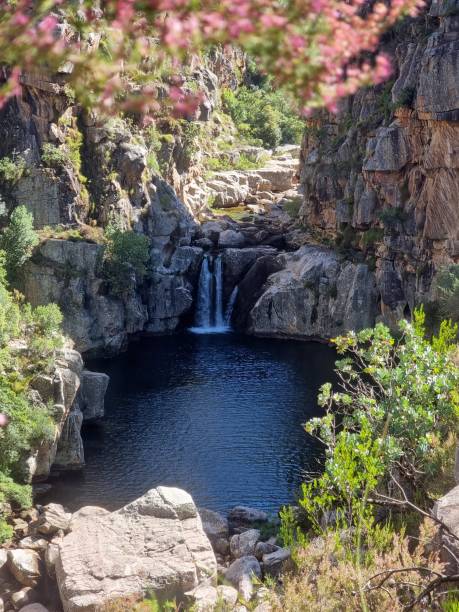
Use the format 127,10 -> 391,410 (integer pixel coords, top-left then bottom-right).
0,206 -> 38,281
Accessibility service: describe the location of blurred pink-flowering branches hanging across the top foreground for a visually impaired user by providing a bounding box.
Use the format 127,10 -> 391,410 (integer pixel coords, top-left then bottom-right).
0,0 -> 423,113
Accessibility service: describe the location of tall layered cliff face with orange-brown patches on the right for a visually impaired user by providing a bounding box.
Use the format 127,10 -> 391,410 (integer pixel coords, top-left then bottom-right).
300,2 -> 459,321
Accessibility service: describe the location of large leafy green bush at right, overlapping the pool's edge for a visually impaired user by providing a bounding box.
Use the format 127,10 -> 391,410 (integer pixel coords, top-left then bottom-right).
284,310 -> 459,539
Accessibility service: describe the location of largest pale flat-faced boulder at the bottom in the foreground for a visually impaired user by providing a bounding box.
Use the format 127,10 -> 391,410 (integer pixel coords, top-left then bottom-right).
55,487 -> 217,612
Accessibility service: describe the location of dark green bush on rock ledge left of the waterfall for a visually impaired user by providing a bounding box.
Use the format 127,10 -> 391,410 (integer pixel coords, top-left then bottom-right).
104,226 -> 150,296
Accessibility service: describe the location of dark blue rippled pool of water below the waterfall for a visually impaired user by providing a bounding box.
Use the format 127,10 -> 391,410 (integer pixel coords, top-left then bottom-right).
48,333 -> 334,512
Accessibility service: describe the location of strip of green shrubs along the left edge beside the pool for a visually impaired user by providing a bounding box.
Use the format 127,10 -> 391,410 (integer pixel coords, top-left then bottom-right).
0,216 -> 63,543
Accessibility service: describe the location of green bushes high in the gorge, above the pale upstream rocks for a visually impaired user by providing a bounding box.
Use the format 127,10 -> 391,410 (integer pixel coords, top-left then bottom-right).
222,85 -> 304,148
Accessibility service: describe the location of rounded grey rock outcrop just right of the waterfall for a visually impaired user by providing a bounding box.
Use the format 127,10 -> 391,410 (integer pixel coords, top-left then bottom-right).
248,246 -> 377,338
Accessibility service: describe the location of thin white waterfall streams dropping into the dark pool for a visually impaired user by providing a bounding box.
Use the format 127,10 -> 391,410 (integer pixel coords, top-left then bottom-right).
190,255 -> 237,334
